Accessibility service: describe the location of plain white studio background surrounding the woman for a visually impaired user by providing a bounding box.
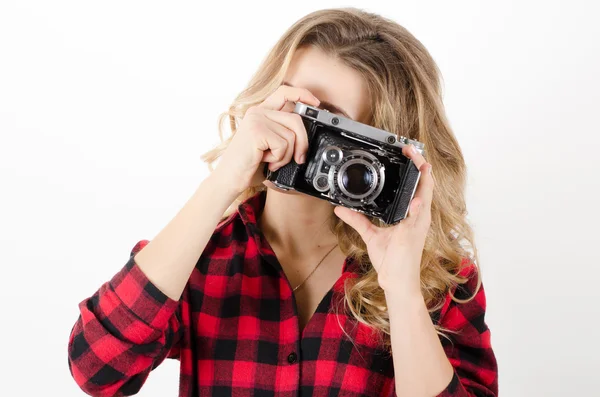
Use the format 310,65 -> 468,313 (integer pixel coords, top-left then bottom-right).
0,0 -> 600,396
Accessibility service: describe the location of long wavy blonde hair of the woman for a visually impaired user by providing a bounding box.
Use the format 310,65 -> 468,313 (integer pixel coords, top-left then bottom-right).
202,7 -> 481,350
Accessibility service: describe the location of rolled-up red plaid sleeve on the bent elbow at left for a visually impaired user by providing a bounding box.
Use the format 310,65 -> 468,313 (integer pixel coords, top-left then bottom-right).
68,240 -> 182,397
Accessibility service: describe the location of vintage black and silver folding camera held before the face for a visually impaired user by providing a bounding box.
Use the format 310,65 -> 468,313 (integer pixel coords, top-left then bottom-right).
264,102 -> 424,224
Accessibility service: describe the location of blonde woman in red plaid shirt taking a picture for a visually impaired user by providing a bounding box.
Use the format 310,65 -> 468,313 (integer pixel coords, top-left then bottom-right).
69,8 -> 498,397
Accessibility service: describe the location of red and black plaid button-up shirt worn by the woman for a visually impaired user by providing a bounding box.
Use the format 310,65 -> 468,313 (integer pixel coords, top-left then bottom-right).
69,193 -> 498,397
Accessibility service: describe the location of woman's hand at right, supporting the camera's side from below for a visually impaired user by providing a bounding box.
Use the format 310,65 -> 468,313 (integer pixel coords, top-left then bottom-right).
334,145 -> 434,294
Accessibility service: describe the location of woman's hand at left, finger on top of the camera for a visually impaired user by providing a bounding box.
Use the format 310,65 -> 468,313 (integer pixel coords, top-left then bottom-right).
213,85 -> 320,194
